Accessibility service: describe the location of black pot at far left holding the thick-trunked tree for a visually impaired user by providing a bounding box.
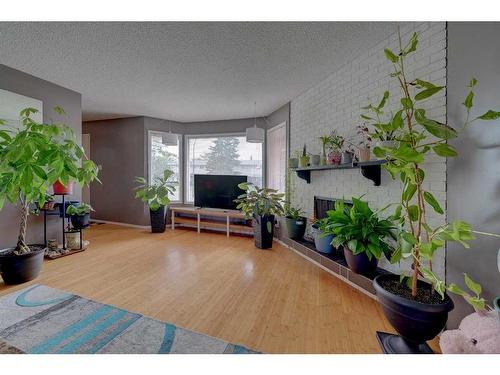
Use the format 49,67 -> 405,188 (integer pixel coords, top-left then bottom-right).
0,245 -> 45,285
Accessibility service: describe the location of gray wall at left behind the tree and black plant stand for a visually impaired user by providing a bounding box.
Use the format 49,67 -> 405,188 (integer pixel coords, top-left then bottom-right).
0,64 -> 82,248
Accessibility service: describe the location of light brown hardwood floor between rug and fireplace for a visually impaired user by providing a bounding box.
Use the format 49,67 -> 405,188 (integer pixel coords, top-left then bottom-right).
0,224 -> 393,353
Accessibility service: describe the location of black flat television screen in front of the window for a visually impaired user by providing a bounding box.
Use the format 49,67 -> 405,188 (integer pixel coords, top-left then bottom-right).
194,174 -> 247,210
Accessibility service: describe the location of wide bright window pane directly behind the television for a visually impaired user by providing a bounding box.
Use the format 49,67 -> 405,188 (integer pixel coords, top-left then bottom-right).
186,136 -> 262,202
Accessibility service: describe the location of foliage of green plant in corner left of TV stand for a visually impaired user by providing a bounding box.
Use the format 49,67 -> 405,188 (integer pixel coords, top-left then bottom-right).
135,169 -> 176,211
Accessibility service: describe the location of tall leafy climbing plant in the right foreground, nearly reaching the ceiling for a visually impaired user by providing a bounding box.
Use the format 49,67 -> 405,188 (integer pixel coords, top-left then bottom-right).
362,29 -> 500,309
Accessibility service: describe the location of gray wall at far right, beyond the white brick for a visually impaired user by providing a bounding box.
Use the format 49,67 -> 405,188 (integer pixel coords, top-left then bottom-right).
446,22 -> 500,328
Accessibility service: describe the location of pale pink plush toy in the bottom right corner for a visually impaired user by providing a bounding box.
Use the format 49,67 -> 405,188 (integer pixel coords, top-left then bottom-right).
439,311 -> 500,354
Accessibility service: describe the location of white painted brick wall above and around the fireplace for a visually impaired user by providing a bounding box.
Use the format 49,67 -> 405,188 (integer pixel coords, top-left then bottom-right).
290,22 -> 446,277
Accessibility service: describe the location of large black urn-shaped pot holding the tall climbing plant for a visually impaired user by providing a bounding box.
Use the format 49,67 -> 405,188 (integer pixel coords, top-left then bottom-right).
373,275 -> 454,354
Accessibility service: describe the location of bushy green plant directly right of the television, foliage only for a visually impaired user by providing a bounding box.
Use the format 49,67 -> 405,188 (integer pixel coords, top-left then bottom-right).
234,182 -> 284,232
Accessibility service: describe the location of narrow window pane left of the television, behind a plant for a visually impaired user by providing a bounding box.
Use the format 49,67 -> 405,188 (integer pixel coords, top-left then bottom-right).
149,133 -> 181,201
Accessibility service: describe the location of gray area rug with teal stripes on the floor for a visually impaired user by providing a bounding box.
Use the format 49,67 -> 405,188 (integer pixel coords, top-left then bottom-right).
0,285 -> 257,354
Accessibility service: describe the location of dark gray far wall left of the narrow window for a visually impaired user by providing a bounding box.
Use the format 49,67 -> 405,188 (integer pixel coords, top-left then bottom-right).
83,117 -> 149,225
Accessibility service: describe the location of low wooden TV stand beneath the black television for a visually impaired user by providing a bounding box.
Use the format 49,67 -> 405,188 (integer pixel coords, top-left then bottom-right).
170,206 -> 253,237
